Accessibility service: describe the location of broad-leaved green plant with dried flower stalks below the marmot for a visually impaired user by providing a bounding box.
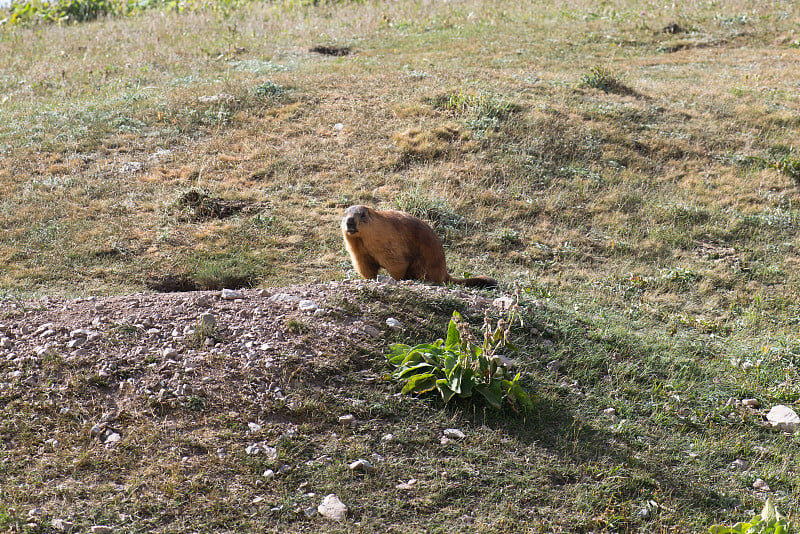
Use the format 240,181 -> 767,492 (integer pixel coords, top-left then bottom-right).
387,310 -> 533,411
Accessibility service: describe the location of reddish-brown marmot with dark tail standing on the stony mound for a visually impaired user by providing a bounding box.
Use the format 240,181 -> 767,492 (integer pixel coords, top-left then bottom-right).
342,206 -> 497,287
